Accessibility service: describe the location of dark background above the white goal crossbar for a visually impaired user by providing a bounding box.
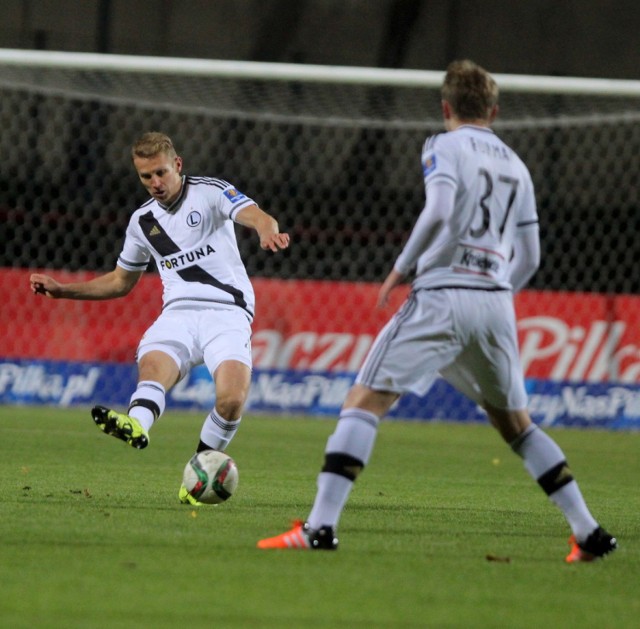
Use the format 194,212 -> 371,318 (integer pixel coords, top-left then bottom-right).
0,0 -> 640,79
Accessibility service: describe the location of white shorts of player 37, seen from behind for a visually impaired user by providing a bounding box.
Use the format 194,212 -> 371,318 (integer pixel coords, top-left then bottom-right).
356,289 -> 527,410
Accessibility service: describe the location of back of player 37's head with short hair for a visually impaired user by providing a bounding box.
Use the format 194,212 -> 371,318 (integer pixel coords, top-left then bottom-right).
441,59 -> 498,120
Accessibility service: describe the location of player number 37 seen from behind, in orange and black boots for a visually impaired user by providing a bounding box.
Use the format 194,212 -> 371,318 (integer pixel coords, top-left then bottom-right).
258,61 -> 617,562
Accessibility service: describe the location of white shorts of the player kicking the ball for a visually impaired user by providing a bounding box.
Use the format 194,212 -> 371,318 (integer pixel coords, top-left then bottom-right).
136,308 -> 252,378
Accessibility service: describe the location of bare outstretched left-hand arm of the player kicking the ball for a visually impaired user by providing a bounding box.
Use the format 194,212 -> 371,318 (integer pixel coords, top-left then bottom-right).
30,266 -> 142,299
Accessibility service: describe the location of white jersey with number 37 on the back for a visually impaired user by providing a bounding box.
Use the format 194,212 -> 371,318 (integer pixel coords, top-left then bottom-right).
395,125 -> 538,289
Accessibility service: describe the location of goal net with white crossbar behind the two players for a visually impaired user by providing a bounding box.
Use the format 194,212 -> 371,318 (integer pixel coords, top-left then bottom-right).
0,51 -> 640,422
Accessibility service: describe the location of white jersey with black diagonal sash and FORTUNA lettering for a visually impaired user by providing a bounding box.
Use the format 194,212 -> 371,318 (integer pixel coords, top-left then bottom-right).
118,177 -> 255,318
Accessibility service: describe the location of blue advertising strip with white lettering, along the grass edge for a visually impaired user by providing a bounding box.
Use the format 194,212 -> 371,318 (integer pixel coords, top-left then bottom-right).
0,360 -> 640,430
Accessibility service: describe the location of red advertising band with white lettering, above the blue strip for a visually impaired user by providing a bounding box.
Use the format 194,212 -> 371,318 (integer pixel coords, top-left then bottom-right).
0,269 -> 640,384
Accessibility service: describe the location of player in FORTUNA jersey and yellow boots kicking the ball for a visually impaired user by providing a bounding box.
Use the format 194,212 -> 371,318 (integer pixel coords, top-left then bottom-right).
31,132 -> 289,504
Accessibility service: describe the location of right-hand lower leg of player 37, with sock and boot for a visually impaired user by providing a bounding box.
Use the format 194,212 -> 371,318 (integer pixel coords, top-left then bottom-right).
485,402 -> 617,563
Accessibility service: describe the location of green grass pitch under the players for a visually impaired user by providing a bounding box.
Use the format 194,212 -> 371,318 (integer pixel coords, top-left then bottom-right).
0,407 -> 640,629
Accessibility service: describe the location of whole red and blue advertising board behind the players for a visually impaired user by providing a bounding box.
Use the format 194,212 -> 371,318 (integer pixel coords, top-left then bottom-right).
0,269 -> 640,428
